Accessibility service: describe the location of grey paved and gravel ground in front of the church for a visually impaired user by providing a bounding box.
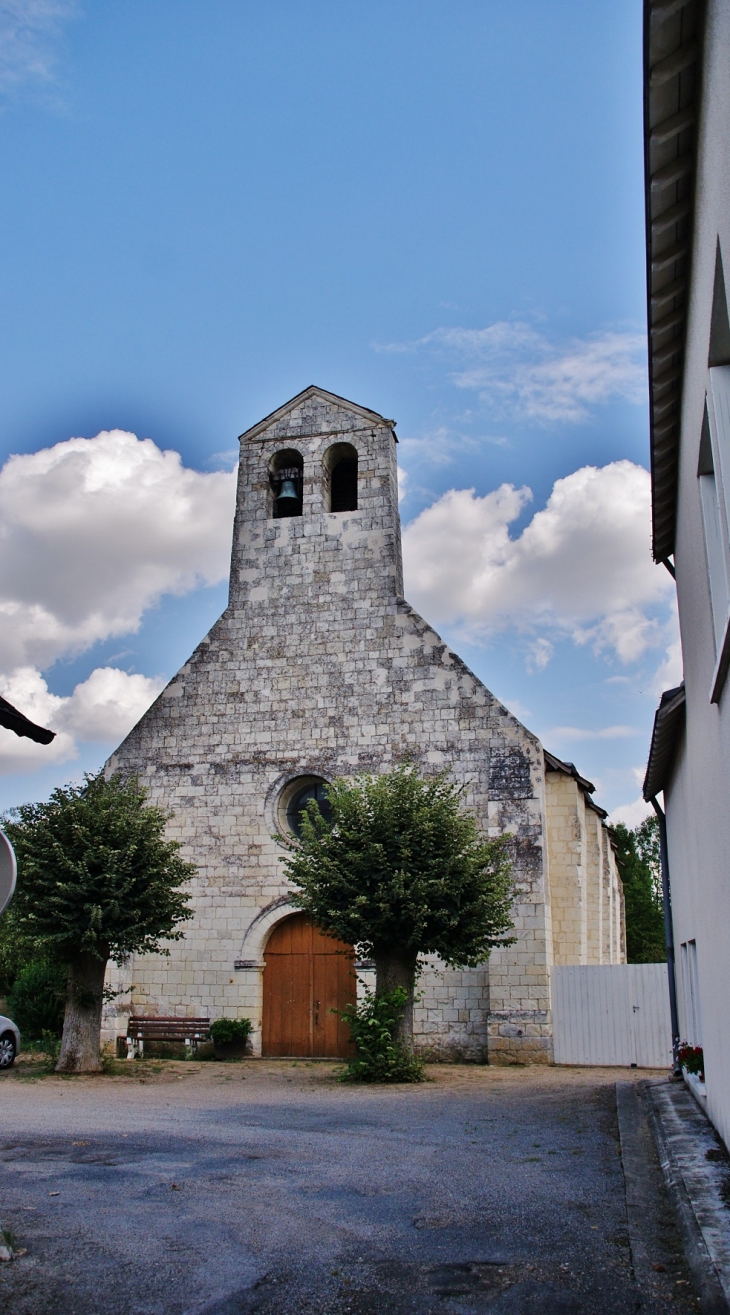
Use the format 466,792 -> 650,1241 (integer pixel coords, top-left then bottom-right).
0,1059 -> 698,1315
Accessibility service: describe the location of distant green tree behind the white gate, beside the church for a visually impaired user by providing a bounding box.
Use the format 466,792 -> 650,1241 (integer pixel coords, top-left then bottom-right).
612,815 -> 667,964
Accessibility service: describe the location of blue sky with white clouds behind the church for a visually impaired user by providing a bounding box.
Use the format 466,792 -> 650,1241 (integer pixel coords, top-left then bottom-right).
0,0 -> 676,809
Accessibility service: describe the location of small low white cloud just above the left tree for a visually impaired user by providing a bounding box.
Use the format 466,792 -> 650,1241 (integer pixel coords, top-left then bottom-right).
0,667 -> 166,775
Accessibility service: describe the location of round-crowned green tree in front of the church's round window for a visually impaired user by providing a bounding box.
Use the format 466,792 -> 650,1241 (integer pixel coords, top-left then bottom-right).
283,767 -> 513,1049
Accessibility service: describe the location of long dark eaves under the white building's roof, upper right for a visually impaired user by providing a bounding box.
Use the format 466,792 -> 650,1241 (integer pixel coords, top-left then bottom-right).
645,0 -> 704,562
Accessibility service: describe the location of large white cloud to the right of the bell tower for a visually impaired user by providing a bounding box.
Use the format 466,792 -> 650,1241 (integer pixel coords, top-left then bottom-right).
404,460 -> 673,665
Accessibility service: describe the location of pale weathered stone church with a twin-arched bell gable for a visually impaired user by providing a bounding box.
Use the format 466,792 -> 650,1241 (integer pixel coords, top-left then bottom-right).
105,388 -> 625,1063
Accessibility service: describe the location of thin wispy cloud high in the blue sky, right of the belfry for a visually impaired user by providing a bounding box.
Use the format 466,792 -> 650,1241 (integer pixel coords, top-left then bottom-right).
380,321 -> 647,423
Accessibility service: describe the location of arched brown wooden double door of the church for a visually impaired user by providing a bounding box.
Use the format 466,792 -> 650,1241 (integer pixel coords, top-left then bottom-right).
262,913 -> 355,1059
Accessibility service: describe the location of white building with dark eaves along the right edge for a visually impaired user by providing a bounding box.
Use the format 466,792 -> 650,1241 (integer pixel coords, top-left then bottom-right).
645,0 -> 730,1143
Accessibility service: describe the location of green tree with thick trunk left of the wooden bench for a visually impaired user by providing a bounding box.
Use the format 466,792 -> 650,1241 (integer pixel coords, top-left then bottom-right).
5,773 -> 195,1073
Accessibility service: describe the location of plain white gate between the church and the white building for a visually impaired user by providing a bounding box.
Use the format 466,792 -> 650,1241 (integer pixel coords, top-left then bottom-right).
550,964 -> 672,1068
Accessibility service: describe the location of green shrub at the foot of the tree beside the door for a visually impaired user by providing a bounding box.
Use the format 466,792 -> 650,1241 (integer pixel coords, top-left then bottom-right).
341,986 -> 424,1082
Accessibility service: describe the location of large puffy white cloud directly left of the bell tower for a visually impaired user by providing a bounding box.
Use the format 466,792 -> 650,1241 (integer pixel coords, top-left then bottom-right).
0,430 -> 235,672
